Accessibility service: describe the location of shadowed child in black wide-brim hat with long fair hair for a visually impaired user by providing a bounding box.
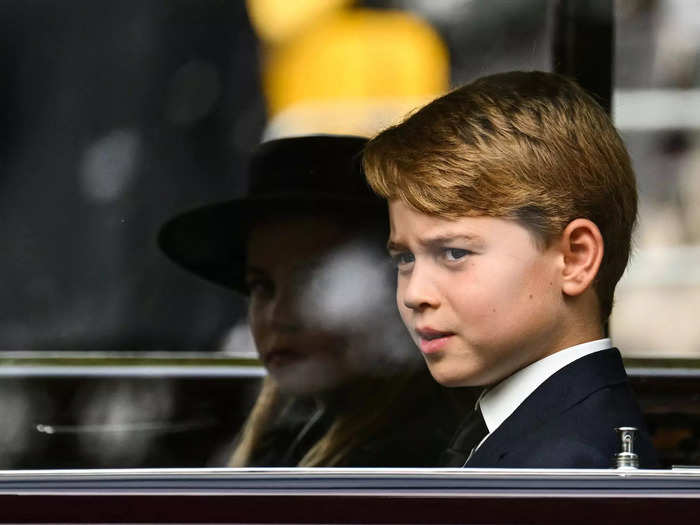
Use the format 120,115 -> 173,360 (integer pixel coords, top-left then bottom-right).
160,135 -> 458,467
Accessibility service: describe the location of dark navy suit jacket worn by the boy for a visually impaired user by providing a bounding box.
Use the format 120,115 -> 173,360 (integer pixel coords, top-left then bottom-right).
465,348 -> 657,468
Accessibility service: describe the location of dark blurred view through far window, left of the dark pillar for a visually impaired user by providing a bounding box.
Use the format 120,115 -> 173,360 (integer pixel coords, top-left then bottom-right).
0,0 -> 550,351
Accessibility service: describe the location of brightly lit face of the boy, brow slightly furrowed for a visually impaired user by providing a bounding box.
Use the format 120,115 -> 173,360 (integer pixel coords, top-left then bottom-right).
389,201 -> 566,386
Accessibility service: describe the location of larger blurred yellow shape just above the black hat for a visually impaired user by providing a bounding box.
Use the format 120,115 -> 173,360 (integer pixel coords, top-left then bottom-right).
263,9 -> 449,117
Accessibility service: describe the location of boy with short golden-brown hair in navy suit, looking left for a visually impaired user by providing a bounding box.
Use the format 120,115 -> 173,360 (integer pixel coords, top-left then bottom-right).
364,72 -> 656,468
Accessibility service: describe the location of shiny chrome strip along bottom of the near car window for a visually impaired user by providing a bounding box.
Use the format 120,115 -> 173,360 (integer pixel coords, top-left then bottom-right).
0,467 -> 700,499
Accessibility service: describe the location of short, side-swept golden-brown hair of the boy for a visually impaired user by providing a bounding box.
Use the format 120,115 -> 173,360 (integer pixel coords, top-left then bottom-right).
363,72 -> 637,321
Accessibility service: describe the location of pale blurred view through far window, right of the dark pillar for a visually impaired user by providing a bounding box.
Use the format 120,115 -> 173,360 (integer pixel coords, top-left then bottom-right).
611,0 -> 700,358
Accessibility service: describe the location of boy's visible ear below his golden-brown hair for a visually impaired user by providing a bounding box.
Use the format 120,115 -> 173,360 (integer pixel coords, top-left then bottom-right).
561,219 -> 604,296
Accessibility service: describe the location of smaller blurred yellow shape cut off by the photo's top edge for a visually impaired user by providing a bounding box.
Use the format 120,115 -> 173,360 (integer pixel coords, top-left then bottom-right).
246,0 -> 353,43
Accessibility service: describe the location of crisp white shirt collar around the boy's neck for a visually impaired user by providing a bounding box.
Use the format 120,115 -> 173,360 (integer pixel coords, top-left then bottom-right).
478,338 -> 612,434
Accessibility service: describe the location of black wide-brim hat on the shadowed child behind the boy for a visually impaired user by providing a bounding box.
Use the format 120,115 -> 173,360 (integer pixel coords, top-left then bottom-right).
158,135 -> 388,293
